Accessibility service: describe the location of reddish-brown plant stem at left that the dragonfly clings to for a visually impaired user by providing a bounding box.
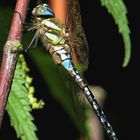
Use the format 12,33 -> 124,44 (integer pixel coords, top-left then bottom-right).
0,0 -> 28,126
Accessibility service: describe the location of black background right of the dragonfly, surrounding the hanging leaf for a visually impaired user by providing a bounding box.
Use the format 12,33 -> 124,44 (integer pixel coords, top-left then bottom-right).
81,0 -> 140,140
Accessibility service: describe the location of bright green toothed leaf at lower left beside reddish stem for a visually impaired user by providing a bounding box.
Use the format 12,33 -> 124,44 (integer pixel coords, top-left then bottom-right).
6,55 -> 38,140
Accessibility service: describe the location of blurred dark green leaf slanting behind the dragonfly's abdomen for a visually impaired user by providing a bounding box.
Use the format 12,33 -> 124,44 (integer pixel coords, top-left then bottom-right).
26,49 -> 86,134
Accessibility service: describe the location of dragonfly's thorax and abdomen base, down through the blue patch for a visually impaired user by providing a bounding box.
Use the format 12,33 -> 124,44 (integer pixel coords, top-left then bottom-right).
34,18 -> 72,66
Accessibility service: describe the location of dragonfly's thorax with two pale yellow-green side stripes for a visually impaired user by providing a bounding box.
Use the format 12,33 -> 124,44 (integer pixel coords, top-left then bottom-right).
33,18 -> 68,46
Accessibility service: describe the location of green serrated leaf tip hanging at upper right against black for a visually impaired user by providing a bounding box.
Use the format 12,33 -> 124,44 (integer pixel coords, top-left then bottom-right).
101,0 -> 131,67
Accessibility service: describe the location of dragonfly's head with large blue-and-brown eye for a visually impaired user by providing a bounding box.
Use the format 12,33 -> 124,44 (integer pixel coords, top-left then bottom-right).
32,4 -> 55,18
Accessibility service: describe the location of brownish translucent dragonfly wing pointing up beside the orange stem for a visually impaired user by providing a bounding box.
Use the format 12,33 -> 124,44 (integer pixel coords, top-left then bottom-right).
66,0 -> 88,71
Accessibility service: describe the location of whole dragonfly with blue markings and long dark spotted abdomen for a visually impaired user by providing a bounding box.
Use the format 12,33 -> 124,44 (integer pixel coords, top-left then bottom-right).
29,0 -> 118,140
